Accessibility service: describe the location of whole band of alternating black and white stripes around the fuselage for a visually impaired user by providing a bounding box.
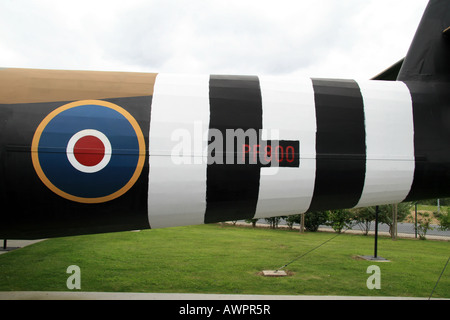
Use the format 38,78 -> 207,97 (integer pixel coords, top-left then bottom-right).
148,74 -> 444,228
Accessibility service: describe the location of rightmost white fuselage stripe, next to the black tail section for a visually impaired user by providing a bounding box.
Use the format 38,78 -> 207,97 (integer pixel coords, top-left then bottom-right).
357,81 -> 415,207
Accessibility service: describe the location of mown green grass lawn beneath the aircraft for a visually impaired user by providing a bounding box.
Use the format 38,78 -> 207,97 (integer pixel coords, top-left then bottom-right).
0,225 -> 450,298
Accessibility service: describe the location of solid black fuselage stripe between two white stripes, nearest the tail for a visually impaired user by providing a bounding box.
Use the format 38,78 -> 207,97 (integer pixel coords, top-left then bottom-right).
308,79 -> 366,211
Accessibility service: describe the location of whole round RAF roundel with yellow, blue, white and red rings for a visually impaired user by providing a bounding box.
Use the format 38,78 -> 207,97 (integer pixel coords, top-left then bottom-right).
31,100 -> 145,203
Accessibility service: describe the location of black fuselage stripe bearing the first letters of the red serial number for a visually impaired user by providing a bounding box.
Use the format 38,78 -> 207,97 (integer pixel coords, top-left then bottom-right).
205,75 -> 262,223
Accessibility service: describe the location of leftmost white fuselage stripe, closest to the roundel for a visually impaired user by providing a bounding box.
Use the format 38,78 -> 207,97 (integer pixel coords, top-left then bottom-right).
148,74 -> 209,228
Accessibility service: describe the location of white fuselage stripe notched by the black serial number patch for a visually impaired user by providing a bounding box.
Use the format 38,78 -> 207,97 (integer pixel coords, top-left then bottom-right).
255,77 -> 316,218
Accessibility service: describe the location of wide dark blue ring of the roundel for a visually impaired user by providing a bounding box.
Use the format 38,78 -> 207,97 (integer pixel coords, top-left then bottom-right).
38,104 -> 139,198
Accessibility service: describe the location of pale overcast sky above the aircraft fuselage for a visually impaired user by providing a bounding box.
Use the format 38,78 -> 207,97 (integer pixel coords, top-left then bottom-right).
0,0 -> 427,79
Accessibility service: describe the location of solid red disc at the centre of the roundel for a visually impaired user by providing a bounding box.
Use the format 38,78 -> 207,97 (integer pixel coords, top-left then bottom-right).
73,136 -> 105,167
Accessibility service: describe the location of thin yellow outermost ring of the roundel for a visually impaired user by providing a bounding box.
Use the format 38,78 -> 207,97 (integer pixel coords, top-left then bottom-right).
31,100 -> 145,203
